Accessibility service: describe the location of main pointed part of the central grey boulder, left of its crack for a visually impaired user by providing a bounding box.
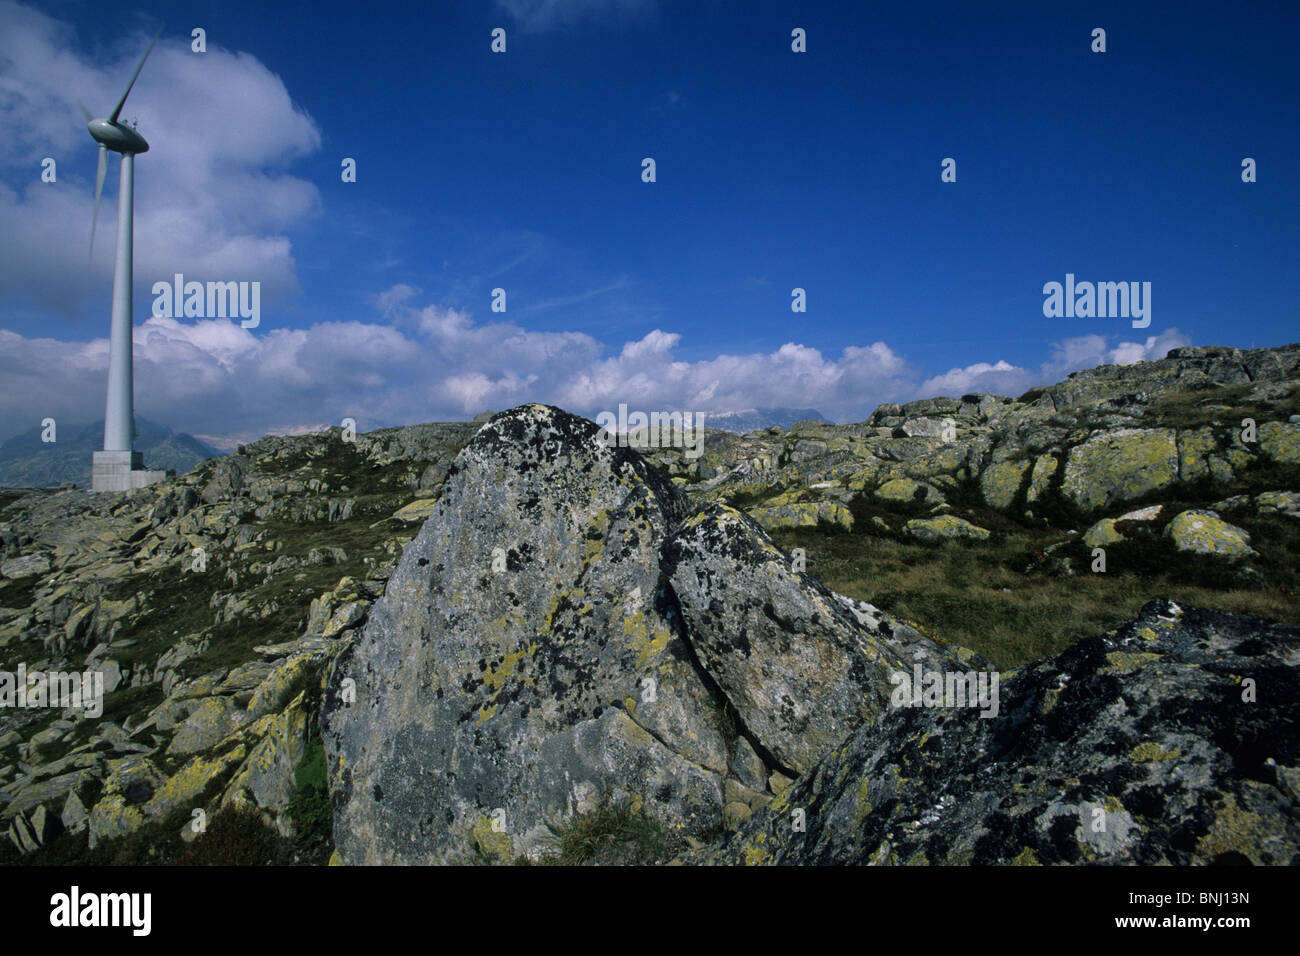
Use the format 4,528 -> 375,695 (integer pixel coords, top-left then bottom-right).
322,405 -> 728,864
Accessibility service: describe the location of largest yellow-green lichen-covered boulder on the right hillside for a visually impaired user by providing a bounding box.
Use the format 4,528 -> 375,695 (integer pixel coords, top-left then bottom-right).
1061,428 -> 1178,512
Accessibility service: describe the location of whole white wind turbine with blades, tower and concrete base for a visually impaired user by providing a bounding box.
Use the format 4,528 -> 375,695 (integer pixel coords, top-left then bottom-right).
81,26 -> 166,492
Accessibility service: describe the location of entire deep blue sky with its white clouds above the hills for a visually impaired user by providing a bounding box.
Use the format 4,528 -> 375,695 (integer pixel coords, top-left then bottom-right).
0,0 -> 1300,441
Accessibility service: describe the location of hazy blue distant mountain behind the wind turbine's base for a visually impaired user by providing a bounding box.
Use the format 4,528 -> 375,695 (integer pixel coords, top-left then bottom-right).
0,418 -> 225,488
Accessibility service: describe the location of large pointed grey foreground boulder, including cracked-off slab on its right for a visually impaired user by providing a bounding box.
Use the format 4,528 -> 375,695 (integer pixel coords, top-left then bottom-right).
322,406 -> 977,864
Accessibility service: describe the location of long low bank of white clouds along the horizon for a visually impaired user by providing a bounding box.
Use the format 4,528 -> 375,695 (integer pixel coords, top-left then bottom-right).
0,285 -> 1190,441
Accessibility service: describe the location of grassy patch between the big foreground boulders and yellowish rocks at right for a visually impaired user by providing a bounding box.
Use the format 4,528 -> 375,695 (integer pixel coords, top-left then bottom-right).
774,512 -> 1300,667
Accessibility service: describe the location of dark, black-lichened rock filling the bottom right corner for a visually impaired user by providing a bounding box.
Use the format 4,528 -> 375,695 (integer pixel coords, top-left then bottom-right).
689,601 -> 1300,865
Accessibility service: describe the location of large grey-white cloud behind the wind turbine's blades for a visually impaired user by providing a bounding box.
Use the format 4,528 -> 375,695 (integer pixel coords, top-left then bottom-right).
0,0 -> 321,315
